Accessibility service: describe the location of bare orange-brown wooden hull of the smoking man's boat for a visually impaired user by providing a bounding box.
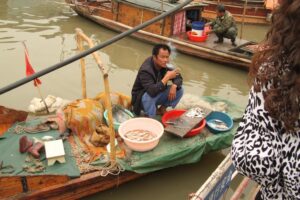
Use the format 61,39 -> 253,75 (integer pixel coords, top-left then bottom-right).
0,106 -> 144,199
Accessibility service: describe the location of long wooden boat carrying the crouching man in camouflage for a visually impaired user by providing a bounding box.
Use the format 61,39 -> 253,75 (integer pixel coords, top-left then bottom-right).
66,0 -> 253,70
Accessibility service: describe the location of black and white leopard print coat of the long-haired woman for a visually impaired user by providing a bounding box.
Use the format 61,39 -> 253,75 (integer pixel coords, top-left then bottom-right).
231,85 -> 300,200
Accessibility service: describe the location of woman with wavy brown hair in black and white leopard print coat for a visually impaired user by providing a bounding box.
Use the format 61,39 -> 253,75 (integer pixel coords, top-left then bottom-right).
231,0 -> 300,199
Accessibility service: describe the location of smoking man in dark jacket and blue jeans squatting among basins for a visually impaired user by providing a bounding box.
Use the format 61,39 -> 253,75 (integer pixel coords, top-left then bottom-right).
131,44 -> 183,118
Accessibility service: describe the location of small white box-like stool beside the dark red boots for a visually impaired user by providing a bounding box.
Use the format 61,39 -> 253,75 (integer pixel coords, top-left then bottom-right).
44,139 -> 66,166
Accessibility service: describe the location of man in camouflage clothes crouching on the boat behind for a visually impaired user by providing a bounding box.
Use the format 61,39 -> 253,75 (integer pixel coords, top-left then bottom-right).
206,4 -> 237,46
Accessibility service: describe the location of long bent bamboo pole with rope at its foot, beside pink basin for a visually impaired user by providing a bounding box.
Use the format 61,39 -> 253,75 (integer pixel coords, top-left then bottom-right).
76,28 -> 116,166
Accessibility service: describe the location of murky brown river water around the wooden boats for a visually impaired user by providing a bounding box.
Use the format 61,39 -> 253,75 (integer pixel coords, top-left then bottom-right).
0,0 -> 267,200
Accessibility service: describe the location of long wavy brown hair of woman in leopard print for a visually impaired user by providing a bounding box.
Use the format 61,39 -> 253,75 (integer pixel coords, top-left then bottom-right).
249,0 -> 300,130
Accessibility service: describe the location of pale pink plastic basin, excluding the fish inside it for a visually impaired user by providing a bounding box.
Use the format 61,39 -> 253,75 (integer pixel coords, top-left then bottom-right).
118,117 -> 164,152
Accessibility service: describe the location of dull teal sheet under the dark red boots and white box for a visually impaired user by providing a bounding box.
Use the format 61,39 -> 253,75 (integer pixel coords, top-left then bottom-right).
0,120 -> 80,177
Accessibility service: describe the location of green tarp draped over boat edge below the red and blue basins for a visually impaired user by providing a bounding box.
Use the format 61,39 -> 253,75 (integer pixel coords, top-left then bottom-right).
118,97 -> 243,173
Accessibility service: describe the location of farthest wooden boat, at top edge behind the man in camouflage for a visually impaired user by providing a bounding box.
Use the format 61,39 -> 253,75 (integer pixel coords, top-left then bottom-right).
202,0 -> 272,24
